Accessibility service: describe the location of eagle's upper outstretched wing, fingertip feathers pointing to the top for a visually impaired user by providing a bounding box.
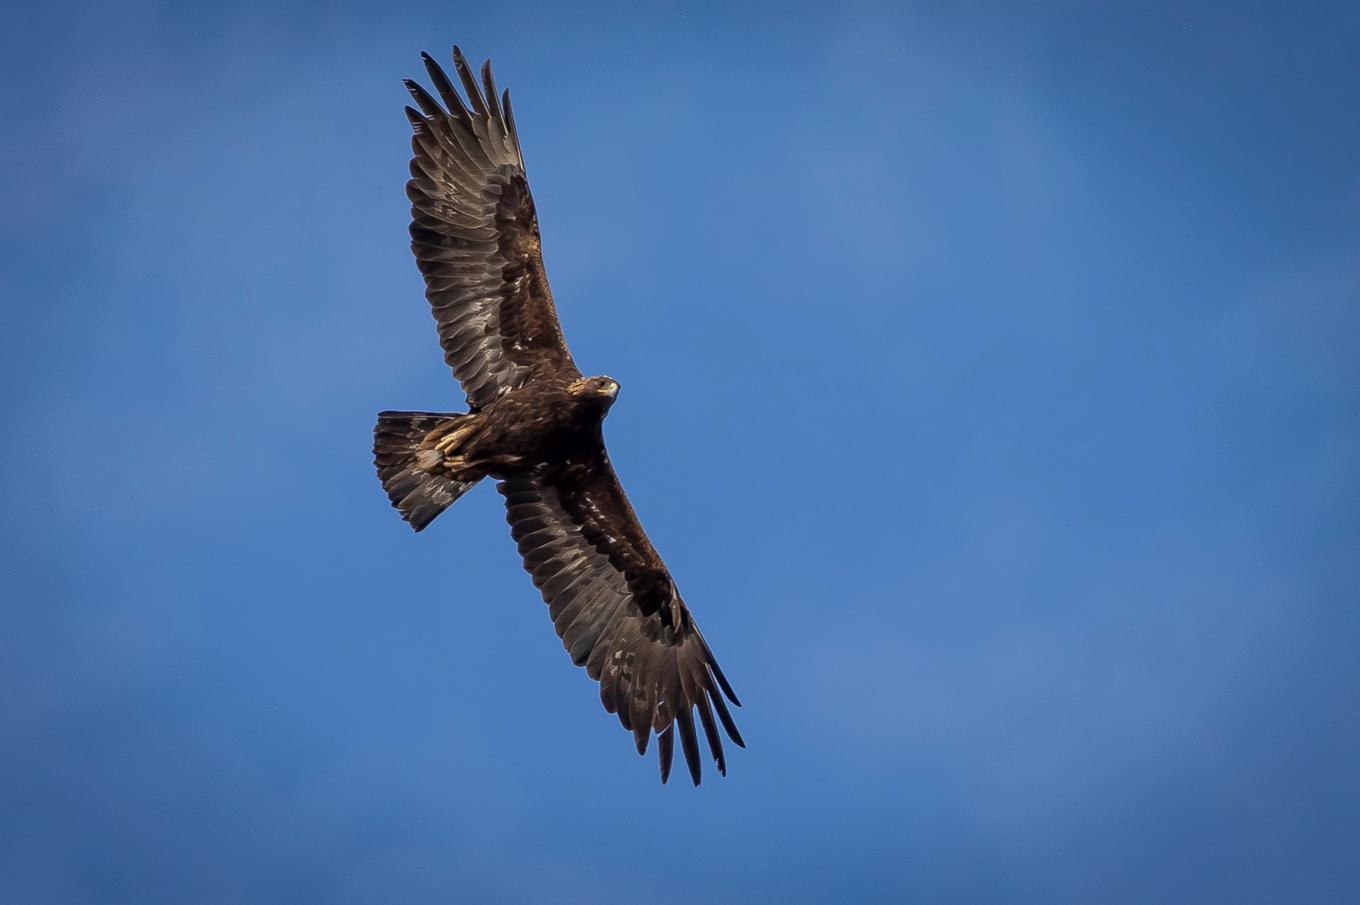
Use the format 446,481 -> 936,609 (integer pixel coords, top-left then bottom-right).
405,48 -> 579,407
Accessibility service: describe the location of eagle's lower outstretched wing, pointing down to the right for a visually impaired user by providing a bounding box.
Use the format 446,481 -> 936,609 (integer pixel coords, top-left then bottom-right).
499,452 -> 745,785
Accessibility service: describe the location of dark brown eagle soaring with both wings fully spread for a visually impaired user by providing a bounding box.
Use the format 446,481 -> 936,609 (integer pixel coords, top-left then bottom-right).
373,48 -> 745,785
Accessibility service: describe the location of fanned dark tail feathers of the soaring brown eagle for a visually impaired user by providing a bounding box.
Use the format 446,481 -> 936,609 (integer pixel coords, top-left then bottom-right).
373,411 -> 477,531
